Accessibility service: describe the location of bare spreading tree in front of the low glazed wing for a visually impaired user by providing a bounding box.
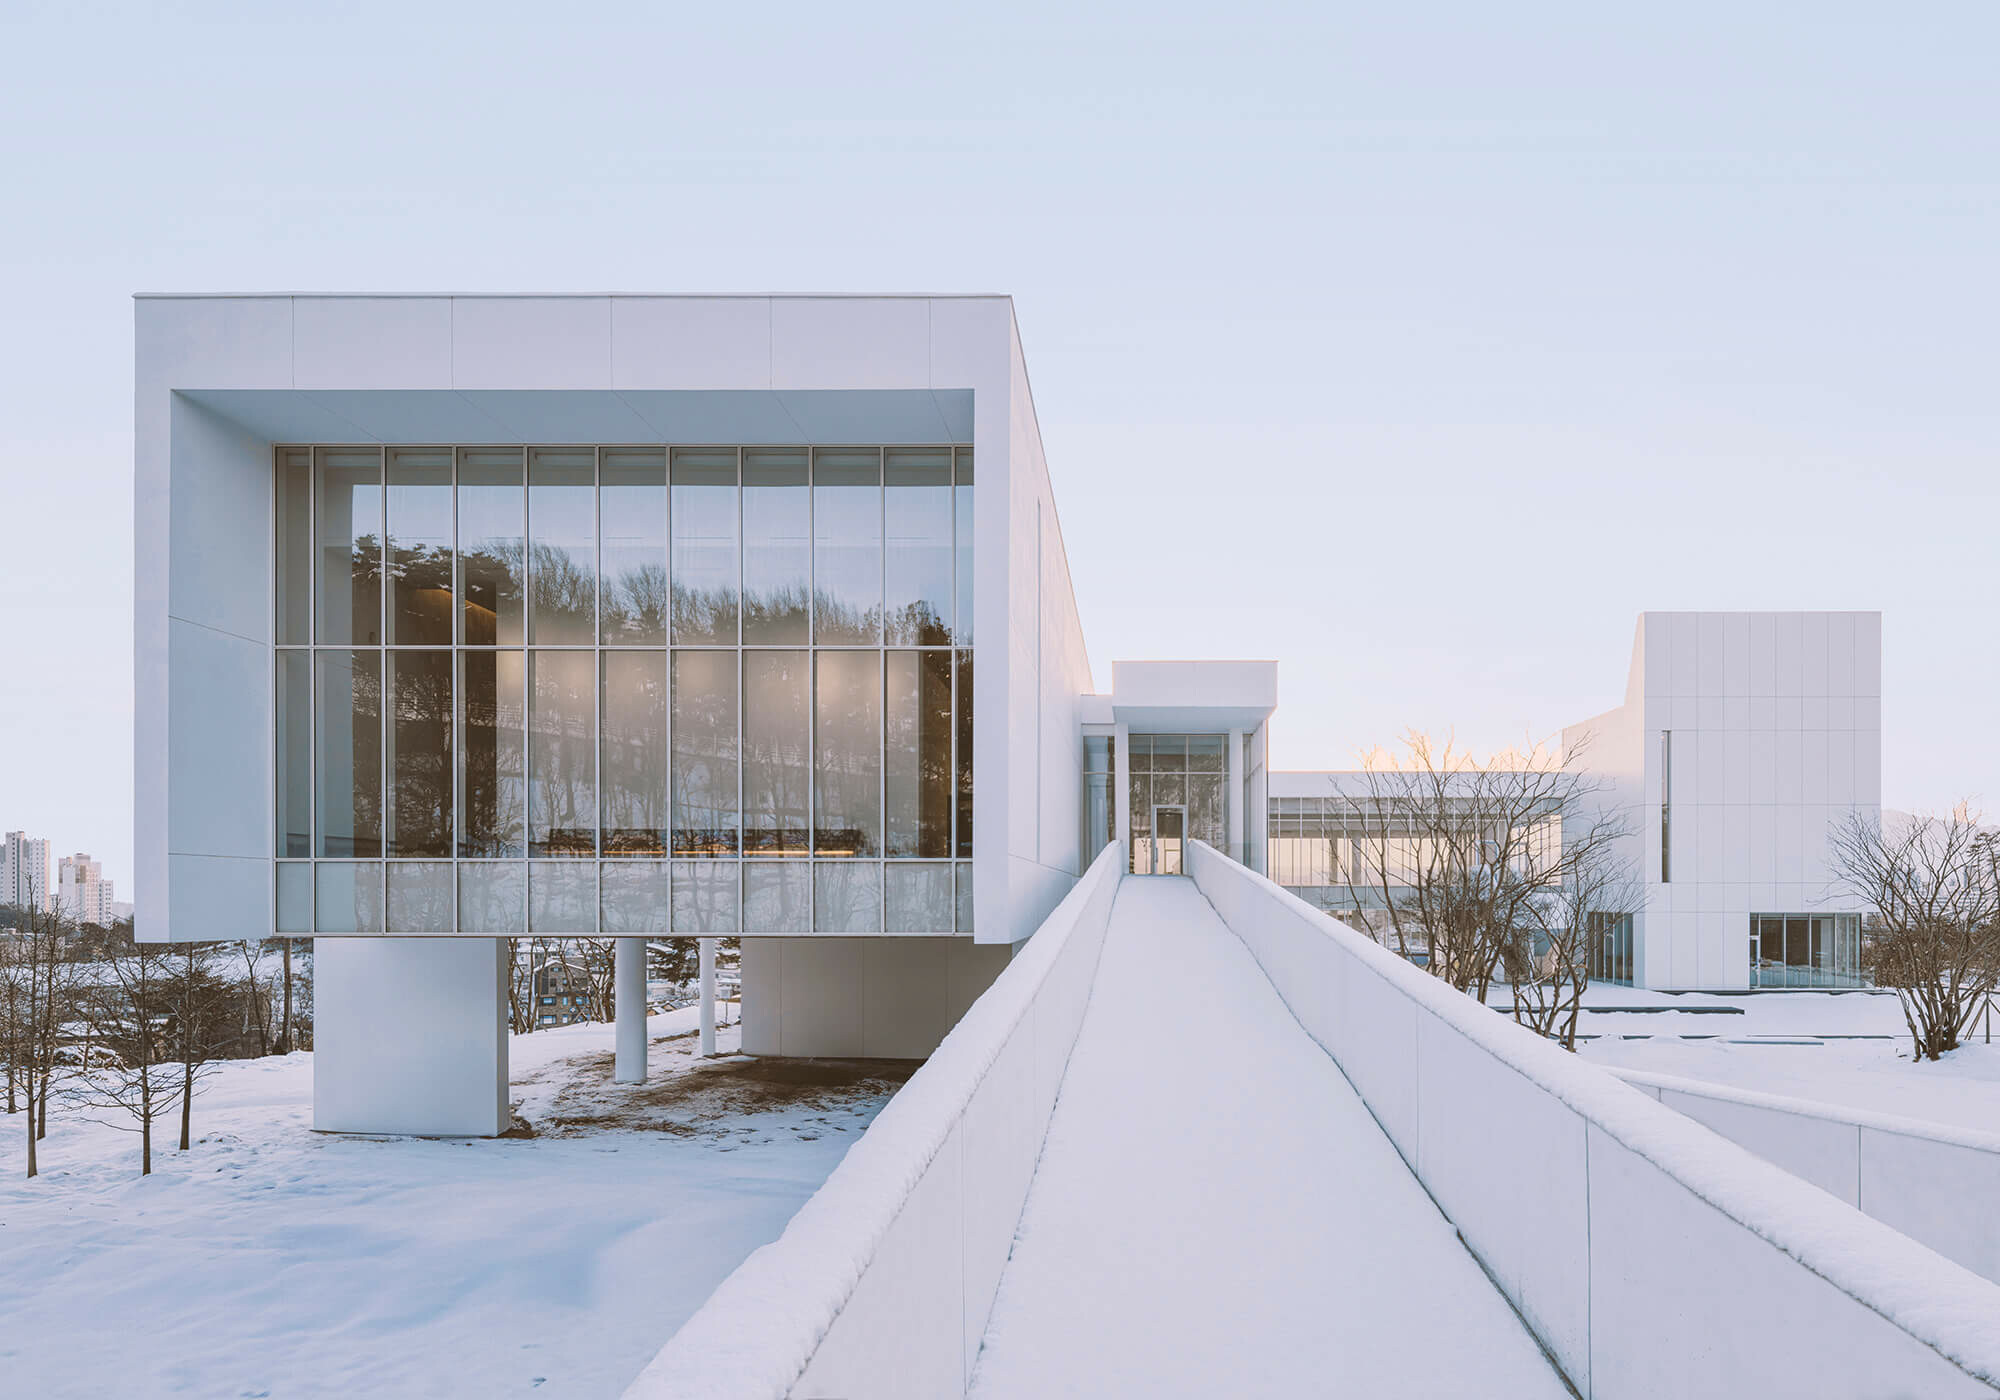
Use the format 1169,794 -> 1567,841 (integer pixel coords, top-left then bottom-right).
1328,730 -> 1636,1046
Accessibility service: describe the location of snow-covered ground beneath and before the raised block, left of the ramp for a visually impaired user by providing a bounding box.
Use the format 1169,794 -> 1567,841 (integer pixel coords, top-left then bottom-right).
0,1008 -> 908,1398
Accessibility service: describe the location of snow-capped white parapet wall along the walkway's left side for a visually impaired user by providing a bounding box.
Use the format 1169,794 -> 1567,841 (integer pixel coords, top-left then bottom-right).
624,842 -> 1126,1400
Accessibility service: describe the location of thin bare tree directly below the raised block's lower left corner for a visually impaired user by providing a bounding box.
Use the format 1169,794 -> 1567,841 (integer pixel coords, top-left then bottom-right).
78,944 -> 182,1176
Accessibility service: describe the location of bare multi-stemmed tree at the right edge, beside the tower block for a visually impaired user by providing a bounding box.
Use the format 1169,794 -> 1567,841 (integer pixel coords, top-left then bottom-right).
1830,802 -> 2000,1060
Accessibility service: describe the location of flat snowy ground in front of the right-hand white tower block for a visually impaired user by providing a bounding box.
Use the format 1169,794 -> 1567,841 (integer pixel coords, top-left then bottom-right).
1536,984 -> 2000,1132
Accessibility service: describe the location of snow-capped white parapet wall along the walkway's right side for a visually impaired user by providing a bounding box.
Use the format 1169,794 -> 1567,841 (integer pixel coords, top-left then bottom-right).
1188,842 -> 2000,1400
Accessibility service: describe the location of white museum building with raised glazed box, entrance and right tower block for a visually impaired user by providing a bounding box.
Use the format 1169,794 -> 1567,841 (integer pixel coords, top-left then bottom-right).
136,296 -> 1880,1134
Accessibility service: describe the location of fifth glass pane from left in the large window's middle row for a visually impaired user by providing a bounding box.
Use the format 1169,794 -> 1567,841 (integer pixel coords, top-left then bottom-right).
528,652 -> 598,856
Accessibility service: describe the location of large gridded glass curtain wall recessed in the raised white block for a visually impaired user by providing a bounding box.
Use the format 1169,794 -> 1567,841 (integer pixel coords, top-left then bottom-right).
274,446 -> 972,934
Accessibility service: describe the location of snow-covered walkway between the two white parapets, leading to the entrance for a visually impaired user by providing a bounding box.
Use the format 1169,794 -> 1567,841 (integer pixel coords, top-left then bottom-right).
972,876 -> 1568,1400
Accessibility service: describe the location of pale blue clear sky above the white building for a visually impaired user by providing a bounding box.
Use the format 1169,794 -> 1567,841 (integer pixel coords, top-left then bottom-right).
0,0 -> 2000,892
